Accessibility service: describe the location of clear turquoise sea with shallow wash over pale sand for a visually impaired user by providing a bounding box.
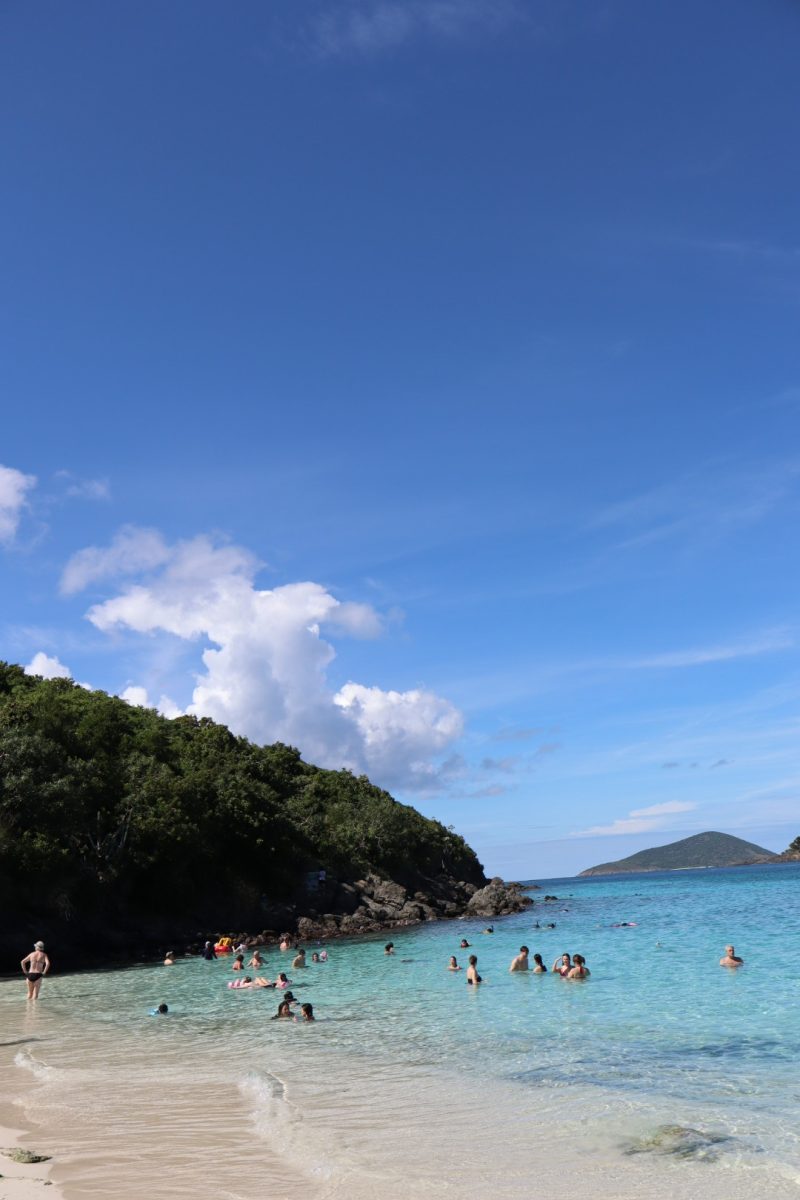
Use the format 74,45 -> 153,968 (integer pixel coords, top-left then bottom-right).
0,864 -> 800,1200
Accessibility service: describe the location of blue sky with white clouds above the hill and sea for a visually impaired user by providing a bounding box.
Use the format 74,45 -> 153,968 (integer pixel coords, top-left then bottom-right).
0,0 -> 800,876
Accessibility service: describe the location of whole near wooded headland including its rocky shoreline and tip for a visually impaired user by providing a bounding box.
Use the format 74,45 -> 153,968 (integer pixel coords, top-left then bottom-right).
0,662 -> 533,971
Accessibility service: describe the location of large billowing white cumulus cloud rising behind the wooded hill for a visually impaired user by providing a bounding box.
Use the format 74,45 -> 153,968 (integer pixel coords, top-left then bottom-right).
81,530 -> 463,787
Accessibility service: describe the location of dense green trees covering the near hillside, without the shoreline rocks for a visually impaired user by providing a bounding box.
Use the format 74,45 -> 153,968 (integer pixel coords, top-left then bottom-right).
0,664 -> 482,919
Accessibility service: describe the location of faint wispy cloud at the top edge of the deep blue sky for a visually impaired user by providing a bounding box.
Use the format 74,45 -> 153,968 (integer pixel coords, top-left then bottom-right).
308,0 -> 527,58
